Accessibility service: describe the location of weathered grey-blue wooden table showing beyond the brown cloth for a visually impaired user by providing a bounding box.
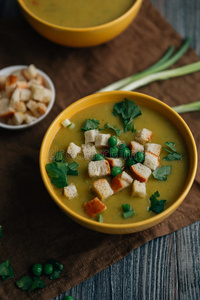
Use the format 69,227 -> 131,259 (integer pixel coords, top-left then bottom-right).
0,0 -> 200,300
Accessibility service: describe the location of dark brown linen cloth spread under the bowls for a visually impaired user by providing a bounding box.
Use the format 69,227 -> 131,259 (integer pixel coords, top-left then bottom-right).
0,0 -> 200,300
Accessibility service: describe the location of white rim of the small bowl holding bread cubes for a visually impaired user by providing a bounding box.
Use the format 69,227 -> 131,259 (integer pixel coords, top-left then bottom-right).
0,65 -> 56,130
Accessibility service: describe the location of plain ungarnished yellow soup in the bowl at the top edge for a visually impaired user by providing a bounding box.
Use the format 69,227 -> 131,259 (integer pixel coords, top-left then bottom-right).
24,0 -> 135,28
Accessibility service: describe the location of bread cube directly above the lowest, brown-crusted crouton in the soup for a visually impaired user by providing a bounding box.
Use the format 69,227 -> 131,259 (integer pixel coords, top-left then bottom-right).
92,179 -> 113,200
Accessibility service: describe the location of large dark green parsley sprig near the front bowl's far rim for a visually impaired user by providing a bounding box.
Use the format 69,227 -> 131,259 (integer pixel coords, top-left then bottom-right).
113,98 -> 142,132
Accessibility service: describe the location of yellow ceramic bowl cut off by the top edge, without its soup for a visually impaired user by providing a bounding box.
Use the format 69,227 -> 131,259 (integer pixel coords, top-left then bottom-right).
18,0 -> 143,47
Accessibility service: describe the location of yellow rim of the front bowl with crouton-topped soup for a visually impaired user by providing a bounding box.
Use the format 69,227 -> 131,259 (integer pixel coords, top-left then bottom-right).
39,91 -> 198,231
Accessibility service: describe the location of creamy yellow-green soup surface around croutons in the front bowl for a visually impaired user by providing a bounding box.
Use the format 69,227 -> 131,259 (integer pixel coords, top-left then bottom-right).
48,103 -> 189,224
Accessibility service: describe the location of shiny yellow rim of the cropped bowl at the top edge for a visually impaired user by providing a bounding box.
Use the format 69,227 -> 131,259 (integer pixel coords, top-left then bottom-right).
17,0 -> 143,32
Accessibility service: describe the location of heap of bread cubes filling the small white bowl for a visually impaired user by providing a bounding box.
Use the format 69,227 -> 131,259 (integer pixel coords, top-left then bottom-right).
0,64 -> 52,125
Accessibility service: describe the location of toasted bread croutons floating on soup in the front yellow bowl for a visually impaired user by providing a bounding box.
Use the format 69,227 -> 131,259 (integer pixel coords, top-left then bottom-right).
64,128 -> 162,217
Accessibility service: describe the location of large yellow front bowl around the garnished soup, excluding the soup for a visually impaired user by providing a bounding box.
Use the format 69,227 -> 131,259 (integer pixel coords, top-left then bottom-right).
40,91 -> 197,234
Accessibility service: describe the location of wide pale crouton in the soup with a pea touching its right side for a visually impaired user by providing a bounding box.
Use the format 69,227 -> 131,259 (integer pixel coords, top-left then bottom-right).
88,160 -> 111,177
